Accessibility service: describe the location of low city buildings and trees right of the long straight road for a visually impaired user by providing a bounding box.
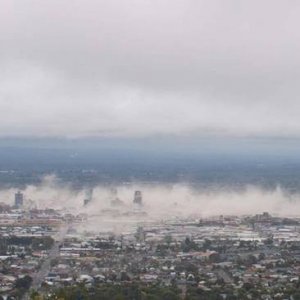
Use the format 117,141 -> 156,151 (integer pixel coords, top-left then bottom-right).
24,213 -> 300,299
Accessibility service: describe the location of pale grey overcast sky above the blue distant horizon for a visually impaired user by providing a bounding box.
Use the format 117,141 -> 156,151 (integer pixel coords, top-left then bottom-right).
0,0 -> 300,137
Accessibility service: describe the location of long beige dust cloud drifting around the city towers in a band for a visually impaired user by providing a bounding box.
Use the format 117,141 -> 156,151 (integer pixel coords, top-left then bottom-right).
0,175 -> 300,219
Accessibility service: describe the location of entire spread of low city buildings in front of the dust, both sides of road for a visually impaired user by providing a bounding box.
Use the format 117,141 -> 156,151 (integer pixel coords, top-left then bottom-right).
0,191 -> 300,300
